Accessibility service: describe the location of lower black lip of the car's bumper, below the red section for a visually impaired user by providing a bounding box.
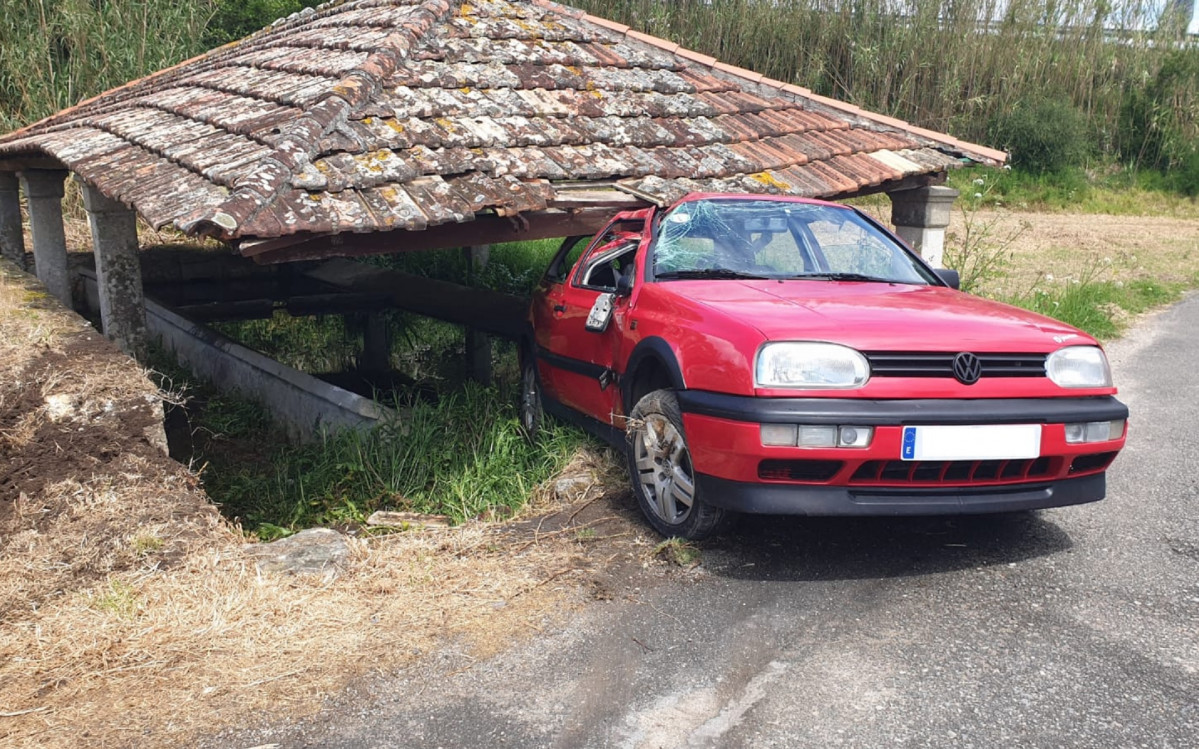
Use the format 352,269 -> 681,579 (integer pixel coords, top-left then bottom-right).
695,473 -> 1107,515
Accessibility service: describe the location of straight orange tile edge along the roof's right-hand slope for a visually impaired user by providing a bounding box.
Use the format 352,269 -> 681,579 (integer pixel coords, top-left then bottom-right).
529,0 -> 1007,165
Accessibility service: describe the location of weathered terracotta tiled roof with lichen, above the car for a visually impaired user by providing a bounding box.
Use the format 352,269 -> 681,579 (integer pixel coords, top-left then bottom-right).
0,0 -> 1005,246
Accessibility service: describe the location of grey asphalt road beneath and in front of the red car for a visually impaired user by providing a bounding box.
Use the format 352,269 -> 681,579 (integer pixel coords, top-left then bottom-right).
223,296 -> 1199,749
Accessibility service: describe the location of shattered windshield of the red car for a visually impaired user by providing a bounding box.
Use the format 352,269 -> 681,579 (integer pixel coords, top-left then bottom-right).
652,199 -> 934,284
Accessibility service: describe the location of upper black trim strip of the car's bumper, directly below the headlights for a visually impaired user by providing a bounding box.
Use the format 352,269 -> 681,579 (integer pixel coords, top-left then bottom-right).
679,391 -> 1128,427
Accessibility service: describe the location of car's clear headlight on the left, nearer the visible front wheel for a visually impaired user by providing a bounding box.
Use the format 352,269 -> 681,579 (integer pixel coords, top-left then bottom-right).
754,343 -> 870,389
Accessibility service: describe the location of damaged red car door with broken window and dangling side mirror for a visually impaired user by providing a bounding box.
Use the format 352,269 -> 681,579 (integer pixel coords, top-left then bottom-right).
532,211 -> 649,424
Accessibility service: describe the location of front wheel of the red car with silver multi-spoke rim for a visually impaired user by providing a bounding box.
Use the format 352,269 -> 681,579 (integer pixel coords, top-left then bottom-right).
625,389 -> 733,540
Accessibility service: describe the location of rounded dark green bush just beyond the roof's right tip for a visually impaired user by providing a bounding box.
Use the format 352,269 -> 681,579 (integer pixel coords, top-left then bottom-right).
989,98 -> 1092,174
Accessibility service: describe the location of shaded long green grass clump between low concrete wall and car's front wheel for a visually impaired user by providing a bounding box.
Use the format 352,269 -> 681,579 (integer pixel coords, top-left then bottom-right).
203,383 -> 586,537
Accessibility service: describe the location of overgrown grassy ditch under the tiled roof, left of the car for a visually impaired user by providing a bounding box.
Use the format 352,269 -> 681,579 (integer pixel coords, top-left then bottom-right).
152,300 -> 591,539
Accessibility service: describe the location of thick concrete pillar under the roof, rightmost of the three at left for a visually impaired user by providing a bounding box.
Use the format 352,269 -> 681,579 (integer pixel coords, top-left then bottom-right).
83,185 -> 146,358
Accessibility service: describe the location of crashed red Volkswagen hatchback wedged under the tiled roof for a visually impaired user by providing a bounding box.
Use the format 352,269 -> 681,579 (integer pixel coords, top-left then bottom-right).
522,194 -> 1128,539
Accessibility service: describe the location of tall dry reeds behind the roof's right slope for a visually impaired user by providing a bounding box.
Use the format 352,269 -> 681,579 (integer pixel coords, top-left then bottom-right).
573,0 -> 1199,165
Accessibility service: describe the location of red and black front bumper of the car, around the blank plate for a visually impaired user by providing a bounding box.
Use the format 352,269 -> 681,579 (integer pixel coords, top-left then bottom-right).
679,391 -> 1128,515
